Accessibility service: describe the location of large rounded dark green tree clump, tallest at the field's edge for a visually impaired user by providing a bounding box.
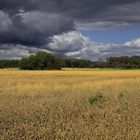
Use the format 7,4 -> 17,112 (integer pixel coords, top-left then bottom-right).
20,52 -> 64,70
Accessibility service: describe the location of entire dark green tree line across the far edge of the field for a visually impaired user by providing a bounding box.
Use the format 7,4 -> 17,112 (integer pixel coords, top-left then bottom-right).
0,52 -> 140,70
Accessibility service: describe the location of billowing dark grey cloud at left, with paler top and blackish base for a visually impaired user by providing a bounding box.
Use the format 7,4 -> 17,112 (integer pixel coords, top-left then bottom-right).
0,11 -> 73,47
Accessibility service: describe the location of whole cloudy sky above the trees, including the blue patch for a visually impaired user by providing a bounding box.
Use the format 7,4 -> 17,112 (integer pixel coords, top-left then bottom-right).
0,0 -> 140,61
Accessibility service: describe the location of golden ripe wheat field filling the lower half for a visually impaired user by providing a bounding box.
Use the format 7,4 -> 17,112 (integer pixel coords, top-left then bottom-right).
0,70 -> 140,140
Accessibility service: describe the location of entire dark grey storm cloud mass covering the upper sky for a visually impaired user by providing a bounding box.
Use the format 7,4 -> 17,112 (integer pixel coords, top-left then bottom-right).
0,0 -> 140,59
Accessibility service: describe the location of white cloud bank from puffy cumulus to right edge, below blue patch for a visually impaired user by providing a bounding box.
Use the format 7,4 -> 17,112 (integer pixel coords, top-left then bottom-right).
48,31 -> 140,61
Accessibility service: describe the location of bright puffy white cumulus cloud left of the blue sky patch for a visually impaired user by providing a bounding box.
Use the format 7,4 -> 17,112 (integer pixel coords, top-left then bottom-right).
48,31 -> 97,52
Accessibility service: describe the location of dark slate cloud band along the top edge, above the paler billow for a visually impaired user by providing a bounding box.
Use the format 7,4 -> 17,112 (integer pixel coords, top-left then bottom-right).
0,0 -> 139,19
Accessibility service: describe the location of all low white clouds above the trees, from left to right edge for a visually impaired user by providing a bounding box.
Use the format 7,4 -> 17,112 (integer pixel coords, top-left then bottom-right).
0,31 -> 140,61
